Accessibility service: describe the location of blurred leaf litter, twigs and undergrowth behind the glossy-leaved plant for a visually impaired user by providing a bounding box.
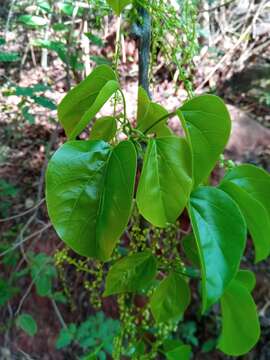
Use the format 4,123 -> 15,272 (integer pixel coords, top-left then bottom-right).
0,0 -> 270,360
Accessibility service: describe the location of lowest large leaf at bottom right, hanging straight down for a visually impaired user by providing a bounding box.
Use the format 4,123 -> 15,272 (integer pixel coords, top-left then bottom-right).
218,277 -> 260,356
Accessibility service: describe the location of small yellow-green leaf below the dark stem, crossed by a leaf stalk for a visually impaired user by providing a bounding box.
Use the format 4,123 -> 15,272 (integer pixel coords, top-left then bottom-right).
137,87 -> 171,136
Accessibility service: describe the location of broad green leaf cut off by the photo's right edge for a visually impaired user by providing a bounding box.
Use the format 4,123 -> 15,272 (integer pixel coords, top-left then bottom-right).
219,164 -> 270,262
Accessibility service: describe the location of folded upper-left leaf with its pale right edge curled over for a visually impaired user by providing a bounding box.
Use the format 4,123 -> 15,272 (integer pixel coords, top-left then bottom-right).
58,65 -> 119,139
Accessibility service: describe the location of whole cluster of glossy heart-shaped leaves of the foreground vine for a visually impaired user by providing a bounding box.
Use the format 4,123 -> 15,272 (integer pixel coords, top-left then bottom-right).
43,49 -> 270,359
